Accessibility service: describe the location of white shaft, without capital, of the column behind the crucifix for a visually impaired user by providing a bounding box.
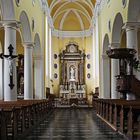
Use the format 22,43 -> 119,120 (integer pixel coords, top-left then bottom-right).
4,26 -> 17,101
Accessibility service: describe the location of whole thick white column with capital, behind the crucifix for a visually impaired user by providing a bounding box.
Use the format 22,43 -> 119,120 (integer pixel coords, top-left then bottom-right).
3,21 -> 19,101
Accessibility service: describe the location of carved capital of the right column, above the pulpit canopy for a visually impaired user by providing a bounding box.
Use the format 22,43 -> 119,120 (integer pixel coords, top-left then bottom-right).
122,22 -> 140,31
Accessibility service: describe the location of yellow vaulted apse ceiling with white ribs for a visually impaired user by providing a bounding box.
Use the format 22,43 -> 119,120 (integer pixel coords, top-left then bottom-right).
47,0 -> 96,31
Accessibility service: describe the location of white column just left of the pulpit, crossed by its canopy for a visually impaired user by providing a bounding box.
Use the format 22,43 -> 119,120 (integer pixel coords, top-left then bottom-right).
111,43 -> 120,99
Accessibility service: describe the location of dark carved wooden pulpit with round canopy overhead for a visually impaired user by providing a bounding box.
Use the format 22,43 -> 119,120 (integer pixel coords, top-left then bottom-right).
106,48 -> 140,99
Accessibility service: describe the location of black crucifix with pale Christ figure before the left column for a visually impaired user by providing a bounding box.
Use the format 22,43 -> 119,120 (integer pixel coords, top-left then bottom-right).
0,44 -> 17,89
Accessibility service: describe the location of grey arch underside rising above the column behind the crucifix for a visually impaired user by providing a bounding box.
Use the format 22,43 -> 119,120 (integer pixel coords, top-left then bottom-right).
0,0 -> 15,20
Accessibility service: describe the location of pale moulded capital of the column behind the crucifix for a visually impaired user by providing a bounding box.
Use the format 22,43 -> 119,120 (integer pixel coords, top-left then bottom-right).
0,20 -> 21,29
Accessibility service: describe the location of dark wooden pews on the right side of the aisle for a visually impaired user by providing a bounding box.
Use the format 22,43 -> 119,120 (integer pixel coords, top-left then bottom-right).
93,99 -> 140,140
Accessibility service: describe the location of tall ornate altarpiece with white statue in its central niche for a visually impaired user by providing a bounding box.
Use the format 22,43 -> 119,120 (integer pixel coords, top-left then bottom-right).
60,42 -> 86,99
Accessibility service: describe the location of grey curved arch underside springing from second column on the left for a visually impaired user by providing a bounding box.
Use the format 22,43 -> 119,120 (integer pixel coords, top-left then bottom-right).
20,11 -> 31,42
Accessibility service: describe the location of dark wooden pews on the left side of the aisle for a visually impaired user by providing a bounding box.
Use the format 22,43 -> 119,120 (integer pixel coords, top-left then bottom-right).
0,99 -> 54,140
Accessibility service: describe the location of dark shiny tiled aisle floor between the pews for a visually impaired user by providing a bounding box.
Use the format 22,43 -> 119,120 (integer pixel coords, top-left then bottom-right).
25,108 -> 126,140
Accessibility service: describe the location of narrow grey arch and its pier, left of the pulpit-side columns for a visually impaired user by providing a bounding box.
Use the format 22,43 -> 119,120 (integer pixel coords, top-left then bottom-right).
101,34 -> 111,99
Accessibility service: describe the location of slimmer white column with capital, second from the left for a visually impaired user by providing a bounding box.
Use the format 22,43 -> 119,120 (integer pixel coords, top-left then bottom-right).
24,43 -> 33,100
